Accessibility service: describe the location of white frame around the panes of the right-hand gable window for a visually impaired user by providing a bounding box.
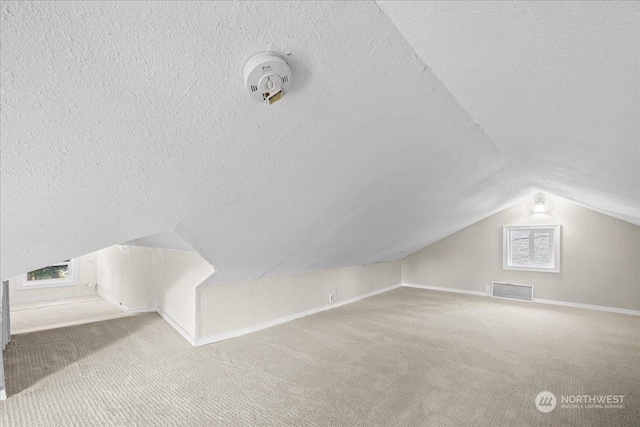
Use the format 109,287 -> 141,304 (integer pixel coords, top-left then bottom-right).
502,224 -> 561,273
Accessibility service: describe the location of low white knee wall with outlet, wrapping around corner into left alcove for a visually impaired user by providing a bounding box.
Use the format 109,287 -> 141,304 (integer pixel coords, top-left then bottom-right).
97,245 -> 401,341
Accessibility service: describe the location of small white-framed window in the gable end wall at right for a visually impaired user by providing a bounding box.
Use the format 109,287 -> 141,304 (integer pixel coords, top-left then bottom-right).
502,225 -> 560,273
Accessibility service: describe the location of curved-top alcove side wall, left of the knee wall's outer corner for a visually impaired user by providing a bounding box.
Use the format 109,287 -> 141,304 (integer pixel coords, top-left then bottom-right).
98,245 -> 213,337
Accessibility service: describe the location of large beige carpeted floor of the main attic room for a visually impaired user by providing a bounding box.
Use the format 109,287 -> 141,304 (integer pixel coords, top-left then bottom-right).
0,288 -> 640,427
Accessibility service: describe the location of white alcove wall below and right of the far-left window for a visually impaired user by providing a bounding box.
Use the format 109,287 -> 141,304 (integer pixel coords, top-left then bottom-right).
9,252 -> 98,303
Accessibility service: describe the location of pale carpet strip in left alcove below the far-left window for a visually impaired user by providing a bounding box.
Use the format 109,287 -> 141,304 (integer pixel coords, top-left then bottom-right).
10,295 -> 130,335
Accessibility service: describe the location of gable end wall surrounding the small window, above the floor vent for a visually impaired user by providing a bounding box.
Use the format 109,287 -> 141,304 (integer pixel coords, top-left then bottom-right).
402,196 -> 640,310
